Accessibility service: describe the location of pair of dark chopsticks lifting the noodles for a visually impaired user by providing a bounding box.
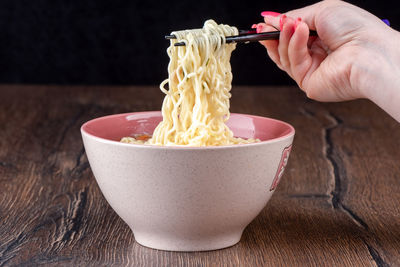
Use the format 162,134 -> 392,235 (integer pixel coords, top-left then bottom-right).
165,30 -> 317,46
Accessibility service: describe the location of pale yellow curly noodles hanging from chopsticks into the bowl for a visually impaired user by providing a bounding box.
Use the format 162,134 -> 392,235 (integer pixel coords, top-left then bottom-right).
121,20 -> 259,146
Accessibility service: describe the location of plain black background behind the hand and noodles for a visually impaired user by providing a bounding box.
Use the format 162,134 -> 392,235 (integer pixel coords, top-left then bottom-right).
0,0 -> 400,85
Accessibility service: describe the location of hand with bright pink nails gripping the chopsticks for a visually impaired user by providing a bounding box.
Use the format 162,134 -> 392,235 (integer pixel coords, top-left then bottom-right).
257,0 -> 400,122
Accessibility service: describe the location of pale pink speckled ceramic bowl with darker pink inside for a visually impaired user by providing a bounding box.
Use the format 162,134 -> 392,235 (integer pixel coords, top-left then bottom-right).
81,111 -> 294,251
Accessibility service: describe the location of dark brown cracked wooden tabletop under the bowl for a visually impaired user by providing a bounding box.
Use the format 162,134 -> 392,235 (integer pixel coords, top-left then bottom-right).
0,85 -> 400,266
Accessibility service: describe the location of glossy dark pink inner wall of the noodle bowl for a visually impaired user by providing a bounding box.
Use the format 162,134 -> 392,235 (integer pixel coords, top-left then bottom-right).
82,111 -> 294,141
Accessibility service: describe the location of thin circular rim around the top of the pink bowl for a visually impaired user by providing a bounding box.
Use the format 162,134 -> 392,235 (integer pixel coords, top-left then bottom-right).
81,111 -> 295,150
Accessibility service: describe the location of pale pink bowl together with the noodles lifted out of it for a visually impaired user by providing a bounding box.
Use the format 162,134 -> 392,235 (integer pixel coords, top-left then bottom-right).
81,19 -> 294,251
